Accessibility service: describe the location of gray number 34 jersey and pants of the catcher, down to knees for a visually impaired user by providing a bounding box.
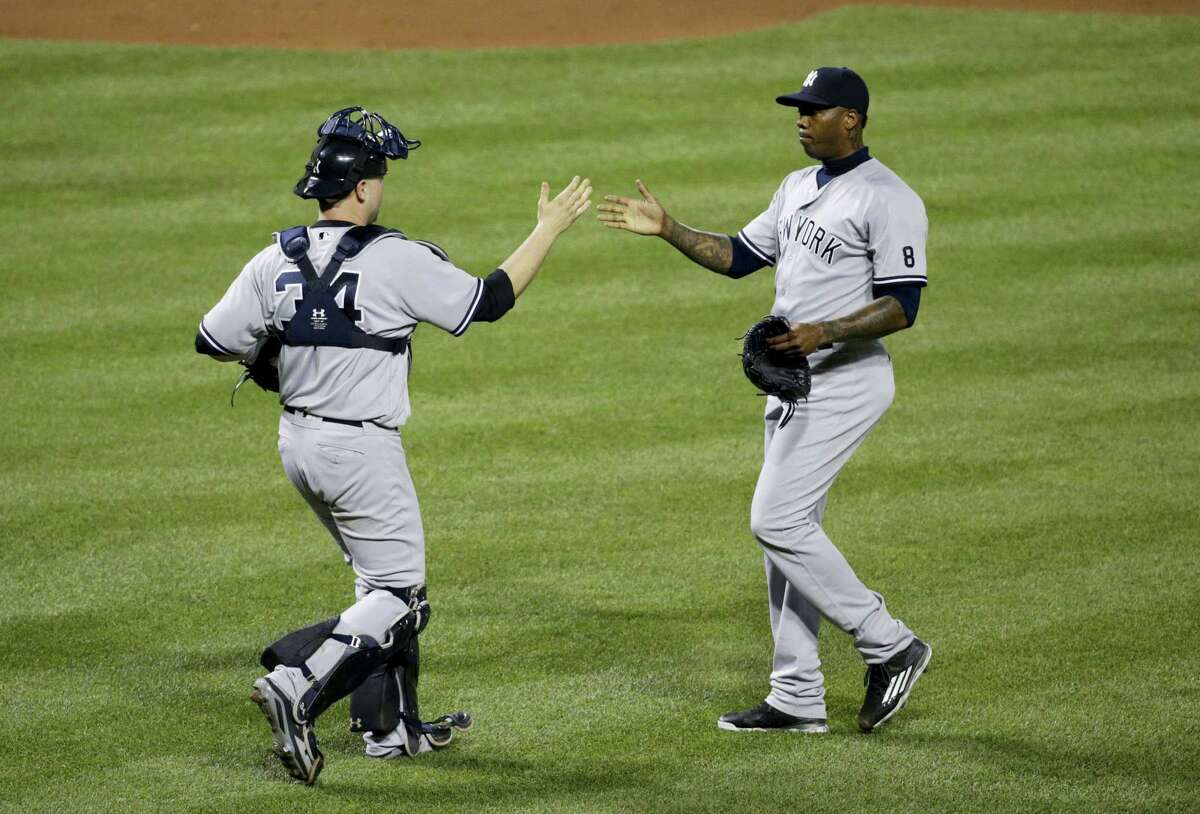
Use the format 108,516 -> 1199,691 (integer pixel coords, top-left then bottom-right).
200,221 -> 484,589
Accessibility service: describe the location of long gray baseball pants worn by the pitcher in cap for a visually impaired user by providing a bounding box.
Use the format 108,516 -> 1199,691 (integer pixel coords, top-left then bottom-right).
750,343 -> 913,718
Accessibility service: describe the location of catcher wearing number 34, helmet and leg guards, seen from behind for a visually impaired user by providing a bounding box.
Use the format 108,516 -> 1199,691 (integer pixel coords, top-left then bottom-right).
196,107 -> 592,784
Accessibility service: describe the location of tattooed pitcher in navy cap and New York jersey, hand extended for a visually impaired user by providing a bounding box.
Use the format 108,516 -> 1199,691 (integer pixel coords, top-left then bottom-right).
599,67 -> 932,732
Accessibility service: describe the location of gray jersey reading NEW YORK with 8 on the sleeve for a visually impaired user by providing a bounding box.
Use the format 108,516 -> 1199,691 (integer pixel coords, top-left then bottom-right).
738,158 -> 929,338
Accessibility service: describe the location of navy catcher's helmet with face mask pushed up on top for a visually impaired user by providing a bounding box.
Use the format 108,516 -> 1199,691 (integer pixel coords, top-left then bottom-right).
293,107 -> 421,198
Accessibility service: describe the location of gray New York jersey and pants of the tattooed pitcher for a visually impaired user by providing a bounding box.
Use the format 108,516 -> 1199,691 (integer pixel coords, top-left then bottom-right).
738,158 -> 928,719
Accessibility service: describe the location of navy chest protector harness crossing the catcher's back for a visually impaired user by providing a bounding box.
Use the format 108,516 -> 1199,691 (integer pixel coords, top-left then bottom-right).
275,226 -> 408,353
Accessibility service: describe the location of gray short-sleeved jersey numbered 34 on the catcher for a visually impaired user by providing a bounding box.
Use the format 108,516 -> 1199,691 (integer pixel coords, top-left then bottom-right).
200,223 -> 484,427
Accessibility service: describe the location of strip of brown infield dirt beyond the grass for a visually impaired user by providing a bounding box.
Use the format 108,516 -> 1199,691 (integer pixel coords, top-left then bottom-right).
0,0 -> 1200,48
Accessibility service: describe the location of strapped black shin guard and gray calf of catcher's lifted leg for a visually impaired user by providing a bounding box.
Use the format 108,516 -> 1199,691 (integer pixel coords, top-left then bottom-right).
296,591 -> 418,722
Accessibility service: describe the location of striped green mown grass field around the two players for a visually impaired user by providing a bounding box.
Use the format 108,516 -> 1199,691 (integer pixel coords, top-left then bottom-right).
0,7 -> 1200,813
